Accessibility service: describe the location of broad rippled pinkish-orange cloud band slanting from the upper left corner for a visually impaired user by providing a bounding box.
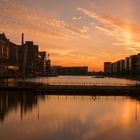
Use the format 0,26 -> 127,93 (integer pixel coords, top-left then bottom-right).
0,0 -> 87,39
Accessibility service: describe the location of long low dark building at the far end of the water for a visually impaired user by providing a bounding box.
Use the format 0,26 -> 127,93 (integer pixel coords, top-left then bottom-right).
51,66 -> 88,75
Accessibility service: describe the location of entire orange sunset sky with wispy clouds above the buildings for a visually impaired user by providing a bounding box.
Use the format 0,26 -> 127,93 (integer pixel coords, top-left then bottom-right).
0,0 -> 140,71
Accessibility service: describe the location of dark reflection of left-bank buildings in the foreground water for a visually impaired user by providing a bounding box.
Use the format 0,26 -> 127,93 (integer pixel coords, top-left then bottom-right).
0,92 -> 45,122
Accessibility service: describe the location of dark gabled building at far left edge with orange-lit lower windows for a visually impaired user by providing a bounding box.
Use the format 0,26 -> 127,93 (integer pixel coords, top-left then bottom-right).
0,33 -> 19,76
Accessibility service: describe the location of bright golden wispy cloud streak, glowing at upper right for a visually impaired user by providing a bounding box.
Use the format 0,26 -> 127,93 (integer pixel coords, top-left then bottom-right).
77,8 -> 140,49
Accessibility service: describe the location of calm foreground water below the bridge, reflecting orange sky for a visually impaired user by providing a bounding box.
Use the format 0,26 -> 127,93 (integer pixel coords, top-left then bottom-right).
0,93 -> 140,140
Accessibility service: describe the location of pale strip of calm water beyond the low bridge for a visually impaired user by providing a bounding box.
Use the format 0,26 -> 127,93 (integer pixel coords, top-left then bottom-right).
23,76 -> 140,86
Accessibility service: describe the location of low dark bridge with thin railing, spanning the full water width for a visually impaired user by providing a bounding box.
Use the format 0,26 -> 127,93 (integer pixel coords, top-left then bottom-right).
0,82 -> 140,95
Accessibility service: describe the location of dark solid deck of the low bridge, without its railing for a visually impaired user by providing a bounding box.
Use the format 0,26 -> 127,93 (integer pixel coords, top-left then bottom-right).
0,84 -> 140,95
